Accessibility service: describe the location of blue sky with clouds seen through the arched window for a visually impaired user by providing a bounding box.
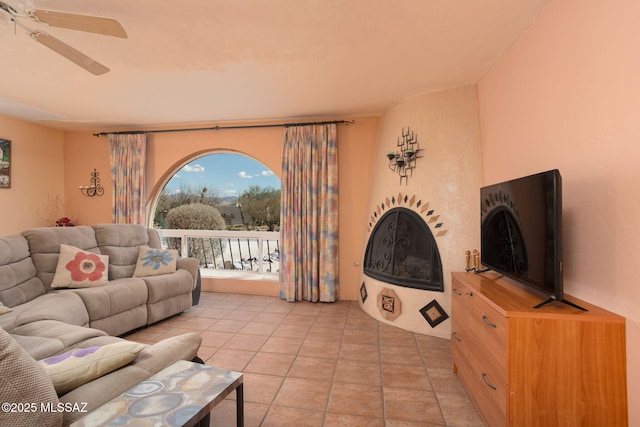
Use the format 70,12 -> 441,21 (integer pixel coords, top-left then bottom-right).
165,153 -> 280,197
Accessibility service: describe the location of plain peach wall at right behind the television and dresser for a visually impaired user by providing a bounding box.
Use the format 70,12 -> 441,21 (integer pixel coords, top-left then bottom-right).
478,0 -> 640,425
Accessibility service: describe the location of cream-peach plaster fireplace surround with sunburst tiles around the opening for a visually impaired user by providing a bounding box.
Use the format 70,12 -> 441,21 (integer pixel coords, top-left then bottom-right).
360,86 -> 482,338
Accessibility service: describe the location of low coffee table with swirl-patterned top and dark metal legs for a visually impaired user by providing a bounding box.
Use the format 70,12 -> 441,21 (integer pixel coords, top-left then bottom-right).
72,360 -> 244,427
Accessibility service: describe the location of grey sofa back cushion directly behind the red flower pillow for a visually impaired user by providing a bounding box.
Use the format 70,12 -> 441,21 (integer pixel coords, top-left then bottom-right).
22,225 -> 100,290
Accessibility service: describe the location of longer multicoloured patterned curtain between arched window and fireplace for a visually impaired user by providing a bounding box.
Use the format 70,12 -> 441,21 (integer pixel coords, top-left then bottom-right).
280,124 -> 339,302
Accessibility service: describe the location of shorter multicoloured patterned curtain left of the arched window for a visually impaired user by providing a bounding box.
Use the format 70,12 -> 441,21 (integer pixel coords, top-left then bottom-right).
109,133 -> 147,225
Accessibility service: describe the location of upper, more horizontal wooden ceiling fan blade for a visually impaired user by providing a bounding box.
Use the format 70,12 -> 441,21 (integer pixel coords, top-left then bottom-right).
26,9 -> 127,39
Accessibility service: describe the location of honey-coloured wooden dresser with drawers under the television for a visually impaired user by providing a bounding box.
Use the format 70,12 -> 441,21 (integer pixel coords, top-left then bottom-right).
451,272 -> 628,427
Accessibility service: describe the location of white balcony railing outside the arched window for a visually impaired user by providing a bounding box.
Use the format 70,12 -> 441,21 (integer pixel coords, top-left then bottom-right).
157,229 -> 280,276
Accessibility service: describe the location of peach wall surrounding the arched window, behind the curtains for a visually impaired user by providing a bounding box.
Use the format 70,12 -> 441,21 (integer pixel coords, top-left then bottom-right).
65,117 -> 379,300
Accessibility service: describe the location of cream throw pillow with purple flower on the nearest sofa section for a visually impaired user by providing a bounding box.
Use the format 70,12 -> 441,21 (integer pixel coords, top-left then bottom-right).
40,340 -> 145,395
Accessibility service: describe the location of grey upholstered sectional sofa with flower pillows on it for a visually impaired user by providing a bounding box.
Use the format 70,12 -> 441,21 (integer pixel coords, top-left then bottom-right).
0,224 -> 201,426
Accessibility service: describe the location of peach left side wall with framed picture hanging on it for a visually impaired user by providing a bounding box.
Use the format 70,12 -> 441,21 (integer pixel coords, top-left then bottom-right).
0,115 -> 65,235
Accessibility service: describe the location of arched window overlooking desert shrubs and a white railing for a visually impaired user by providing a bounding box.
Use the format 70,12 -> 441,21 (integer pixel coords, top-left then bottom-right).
151,153 -> 280,275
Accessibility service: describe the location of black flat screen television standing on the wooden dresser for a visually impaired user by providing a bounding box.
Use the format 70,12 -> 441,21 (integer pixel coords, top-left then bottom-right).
480,169 -> 581,308
